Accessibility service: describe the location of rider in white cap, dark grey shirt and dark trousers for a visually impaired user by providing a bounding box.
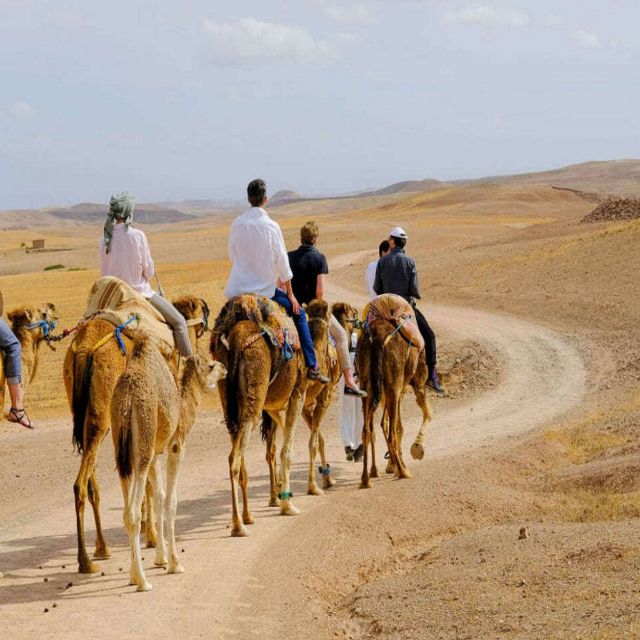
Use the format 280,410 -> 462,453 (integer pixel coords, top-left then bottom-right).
373,227 -> 444,393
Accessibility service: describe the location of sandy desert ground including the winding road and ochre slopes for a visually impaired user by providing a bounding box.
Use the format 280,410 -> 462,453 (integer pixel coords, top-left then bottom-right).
0,163 -> 640,640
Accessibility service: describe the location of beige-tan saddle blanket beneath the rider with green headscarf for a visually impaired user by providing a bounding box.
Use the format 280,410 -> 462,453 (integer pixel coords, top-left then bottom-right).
83,276 -> 175,350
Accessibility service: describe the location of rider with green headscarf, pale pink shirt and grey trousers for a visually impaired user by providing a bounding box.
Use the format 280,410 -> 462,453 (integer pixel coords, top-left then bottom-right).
100,192 -> 191,357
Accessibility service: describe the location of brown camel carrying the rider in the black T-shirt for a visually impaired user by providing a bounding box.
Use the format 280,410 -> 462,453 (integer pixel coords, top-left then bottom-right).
302,300 -> 341,496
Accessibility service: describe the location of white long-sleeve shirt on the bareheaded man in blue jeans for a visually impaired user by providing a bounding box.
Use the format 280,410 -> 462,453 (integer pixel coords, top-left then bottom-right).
224,207 -> 293,298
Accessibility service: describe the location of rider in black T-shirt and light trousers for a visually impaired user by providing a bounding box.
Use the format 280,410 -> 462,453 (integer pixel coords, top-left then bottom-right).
289,221 -> 367,398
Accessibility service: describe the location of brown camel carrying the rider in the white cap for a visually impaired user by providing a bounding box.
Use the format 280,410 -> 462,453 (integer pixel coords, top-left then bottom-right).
356,298 -> 432,489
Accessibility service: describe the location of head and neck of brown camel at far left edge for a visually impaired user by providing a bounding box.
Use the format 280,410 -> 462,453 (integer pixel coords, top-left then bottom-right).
0,302 -> 58,408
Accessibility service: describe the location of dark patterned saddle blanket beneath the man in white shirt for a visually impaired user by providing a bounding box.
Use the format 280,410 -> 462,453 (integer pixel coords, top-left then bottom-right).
211,294 -> 300,351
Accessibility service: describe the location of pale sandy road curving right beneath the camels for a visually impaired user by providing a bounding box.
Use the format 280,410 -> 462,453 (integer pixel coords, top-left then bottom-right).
0,276 -> 585,640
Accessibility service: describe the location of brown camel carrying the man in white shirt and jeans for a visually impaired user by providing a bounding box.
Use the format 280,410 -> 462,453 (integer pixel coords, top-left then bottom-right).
211,296 -> 307,537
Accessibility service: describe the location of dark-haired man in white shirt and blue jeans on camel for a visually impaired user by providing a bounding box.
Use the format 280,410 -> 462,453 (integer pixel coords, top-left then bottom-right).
224,179 -> 329,384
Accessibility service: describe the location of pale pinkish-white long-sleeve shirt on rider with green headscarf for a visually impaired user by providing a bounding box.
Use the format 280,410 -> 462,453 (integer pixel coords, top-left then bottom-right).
99,224 -> 155,298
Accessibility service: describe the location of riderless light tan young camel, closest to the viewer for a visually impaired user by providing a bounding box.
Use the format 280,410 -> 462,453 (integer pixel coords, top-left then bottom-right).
111,336 -> 226,591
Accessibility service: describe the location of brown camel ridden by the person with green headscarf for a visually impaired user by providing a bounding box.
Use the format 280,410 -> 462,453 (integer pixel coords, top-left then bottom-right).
64,296 -> 209,573
